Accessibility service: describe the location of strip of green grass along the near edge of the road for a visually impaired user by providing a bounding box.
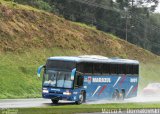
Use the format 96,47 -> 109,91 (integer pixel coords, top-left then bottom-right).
0,103 -> 160,114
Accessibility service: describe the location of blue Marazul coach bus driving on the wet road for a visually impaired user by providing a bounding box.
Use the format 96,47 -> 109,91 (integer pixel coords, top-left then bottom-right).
38,55 -> 139,104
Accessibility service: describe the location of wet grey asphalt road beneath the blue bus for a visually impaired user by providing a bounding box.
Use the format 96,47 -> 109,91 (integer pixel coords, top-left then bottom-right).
0,97 -> 160,109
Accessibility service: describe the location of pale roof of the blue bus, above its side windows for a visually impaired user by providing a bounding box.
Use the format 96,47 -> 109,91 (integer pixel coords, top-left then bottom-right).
48,55 -> 139,64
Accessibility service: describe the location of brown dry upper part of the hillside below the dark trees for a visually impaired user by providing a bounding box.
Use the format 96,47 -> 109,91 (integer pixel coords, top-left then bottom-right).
0,4 -> 158,61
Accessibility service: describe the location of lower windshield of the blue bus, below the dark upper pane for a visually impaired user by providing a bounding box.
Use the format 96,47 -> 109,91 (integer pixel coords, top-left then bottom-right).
43,70 -> 73,88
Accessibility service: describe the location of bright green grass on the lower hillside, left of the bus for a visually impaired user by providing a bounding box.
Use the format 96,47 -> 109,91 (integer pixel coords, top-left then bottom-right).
0,48 -> 82,98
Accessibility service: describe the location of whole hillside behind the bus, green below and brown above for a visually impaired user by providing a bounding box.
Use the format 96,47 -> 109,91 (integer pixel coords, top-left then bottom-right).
0,0 -> 160,98
